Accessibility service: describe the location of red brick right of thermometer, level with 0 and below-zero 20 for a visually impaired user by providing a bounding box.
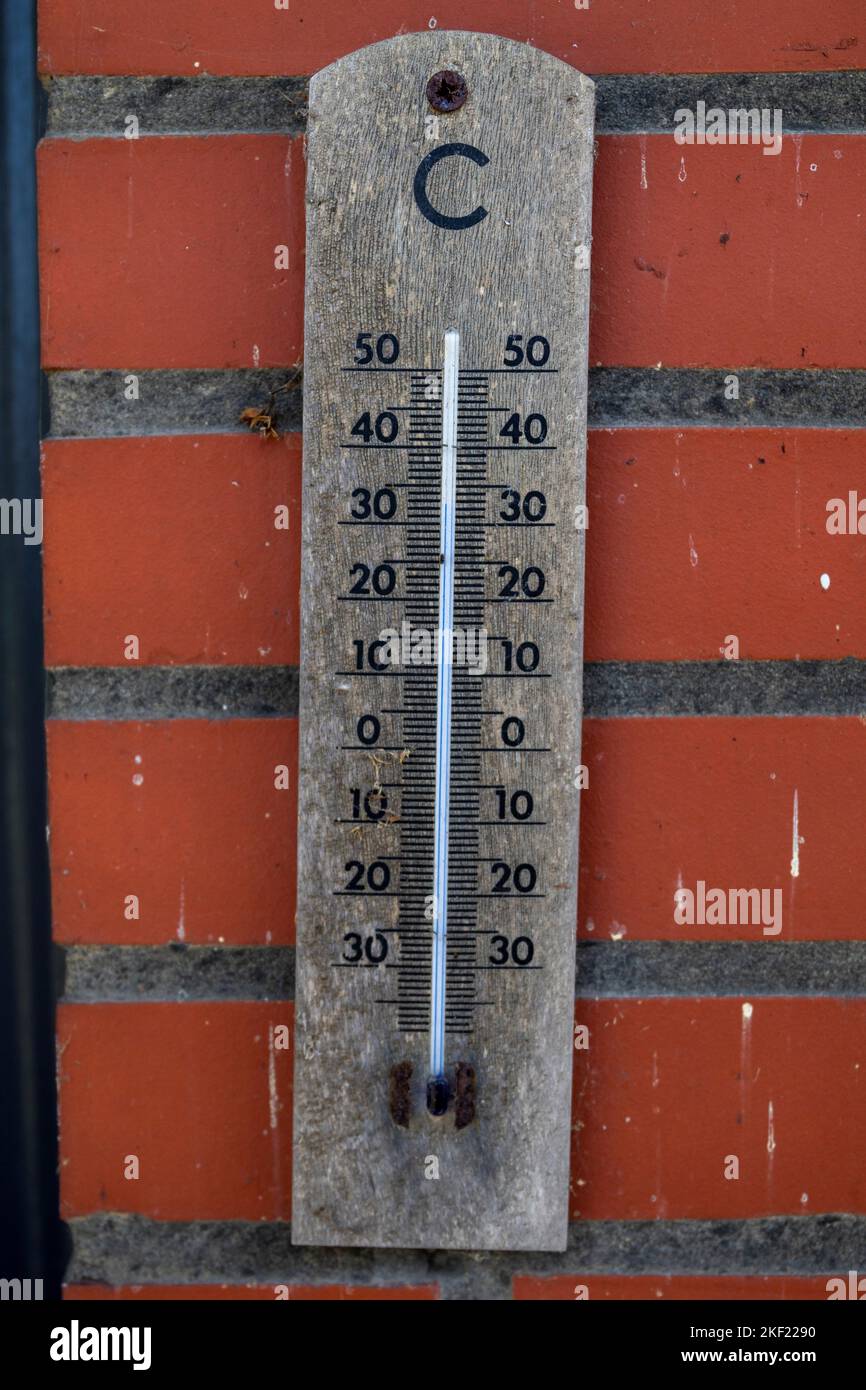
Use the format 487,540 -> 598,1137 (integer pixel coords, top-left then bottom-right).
578,719 -> 866,949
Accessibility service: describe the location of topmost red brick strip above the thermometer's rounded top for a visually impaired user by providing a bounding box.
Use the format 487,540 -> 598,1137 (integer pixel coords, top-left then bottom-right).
39,0 -> 866,76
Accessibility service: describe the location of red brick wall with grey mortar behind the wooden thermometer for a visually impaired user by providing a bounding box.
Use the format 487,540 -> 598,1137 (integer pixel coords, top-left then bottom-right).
39,0 -> 866,1298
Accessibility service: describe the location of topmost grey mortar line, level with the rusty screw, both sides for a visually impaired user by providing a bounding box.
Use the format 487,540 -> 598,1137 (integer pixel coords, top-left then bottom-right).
42,70 -> 866,139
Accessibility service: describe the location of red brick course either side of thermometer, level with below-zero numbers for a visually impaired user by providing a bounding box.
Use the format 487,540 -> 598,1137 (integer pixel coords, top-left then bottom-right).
49,717 -> 866,947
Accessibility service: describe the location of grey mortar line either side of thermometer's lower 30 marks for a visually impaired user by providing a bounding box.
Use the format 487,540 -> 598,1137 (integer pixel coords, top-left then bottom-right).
56,929 -> 866,1004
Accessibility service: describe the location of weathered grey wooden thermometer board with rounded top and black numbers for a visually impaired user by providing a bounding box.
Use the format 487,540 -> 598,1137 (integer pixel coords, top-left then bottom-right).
292,31 -> 594,1250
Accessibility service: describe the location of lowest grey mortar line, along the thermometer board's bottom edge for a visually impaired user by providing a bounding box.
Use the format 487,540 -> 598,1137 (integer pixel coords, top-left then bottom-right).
65,1212 -> 866,1300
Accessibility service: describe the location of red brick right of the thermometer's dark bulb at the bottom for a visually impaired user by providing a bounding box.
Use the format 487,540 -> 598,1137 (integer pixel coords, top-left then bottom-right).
571,1000 -> 866,1220
